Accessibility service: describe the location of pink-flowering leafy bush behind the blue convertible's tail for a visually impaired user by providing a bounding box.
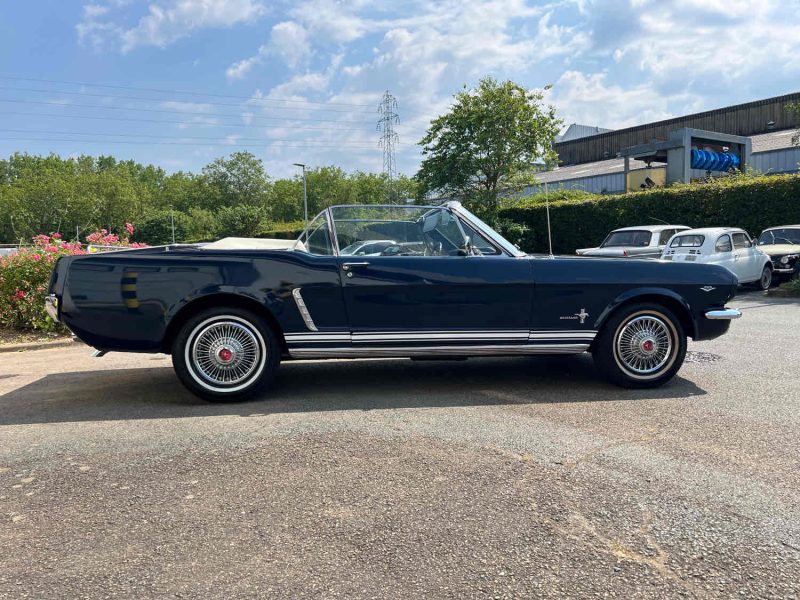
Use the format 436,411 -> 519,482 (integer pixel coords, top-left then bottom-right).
0,233 -> 85,331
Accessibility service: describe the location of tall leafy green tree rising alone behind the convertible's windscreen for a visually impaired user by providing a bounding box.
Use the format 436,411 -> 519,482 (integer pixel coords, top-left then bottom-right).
415,77 -> 561,219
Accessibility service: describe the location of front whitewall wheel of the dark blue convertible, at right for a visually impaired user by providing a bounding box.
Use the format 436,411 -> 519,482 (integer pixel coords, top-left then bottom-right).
592,303 -> 686,388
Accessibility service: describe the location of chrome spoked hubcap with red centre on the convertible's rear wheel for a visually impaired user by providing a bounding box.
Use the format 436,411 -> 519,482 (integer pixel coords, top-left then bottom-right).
192,321 -> 261,385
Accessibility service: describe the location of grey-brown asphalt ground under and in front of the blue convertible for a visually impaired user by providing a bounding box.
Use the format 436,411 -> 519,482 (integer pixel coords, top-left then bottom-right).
0,293 -> 800,598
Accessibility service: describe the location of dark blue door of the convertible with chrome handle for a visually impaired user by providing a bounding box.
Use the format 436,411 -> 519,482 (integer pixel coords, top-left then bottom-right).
339,209 -> 533,346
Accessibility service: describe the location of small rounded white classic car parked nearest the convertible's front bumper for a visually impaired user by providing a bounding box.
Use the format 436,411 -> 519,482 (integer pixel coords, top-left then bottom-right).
661,227 -> 772,290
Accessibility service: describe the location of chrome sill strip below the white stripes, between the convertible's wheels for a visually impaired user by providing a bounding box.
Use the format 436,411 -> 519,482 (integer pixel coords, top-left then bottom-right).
289,344 -> 589,358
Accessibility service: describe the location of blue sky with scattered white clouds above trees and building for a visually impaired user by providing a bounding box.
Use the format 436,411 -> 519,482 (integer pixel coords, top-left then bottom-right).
0,0 -> 800,177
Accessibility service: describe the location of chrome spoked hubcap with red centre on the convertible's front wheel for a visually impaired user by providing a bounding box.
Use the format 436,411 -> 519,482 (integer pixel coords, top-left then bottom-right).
617,315 -> 672,375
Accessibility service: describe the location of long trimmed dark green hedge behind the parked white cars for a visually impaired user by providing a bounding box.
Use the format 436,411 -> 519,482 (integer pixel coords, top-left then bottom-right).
499,175 -> 800,254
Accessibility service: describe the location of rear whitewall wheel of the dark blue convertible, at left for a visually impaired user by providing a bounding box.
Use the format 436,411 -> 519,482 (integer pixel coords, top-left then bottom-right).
172,307 -> 280,402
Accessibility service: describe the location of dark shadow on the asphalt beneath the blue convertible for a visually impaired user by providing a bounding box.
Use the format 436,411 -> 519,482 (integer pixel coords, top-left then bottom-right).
0,356 -> 706,425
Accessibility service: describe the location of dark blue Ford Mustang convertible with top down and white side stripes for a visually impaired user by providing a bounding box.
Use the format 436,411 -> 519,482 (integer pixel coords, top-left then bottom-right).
46,202 -> 741,401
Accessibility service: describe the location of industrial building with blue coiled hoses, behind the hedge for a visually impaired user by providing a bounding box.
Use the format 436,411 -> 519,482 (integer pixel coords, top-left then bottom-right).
525,92 -> 800,195
